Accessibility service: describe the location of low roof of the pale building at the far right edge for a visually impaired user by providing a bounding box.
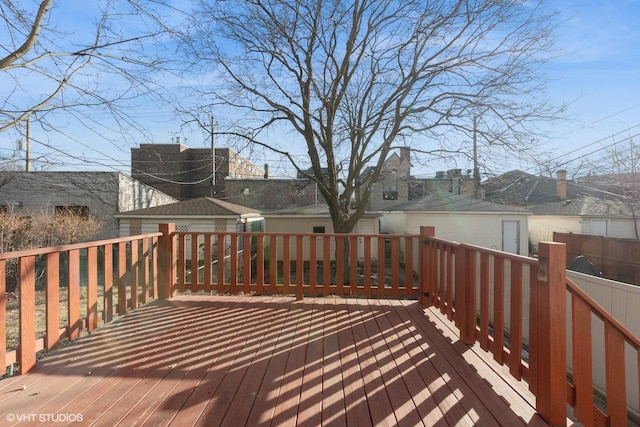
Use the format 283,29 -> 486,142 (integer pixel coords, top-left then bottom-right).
531,196 -> 640,218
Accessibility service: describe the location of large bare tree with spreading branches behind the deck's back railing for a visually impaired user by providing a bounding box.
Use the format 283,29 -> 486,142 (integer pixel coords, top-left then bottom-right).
184,0 -> 554,232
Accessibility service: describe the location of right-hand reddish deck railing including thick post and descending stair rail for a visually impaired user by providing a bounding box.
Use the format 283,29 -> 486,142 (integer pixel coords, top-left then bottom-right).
421,227 -> 640,426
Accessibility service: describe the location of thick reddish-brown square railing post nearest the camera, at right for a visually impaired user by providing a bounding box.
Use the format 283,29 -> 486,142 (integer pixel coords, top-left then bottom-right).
530,242 -> 567,426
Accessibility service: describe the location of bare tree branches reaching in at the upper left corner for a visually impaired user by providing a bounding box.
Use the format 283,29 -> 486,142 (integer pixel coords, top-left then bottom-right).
0,0 -> 175,169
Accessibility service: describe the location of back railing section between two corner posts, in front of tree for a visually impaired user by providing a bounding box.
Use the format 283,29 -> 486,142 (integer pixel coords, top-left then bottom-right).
172,232 -> 419,299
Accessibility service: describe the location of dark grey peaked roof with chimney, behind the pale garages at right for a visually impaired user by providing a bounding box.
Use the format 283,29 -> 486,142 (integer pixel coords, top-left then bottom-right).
482,170 -> 620,205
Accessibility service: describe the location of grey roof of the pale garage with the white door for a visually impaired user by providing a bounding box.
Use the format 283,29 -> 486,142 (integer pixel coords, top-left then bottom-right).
382,191 -> 531,215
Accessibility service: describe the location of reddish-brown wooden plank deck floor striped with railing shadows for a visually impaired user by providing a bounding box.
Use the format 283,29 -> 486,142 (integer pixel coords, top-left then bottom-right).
0,296 -> 546,426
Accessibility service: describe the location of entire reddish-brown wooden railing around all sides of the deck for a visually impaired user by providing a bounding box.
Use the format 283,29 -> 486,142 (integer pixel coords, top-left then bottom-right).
0,224 -> 640,426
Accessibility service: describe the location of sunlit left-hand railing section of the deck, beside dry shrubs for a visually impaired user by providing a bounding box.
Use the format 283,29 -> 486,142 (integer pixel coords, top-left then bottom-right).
0,233 -> 161,374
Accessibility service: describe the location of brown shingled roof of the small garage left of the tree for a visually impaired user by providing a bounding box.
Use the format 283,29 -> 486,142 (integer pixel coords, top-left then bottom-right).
117,197 -> 260,217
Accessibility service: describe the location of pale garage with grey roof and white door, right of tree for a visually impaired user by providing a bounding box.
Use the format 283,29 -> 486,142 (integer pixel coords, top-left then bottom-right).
380,192 -> 531,255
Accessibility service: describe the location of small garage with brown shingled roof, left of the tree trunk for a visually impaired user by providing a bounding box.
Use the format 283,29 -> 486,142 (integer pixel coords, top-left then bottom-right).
117,197 -> 264,237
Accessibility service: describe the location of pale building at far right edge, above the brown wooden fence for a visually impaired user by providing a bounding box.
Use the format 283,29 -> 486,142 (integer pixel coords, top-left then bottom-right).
529,196 -> 640,246
